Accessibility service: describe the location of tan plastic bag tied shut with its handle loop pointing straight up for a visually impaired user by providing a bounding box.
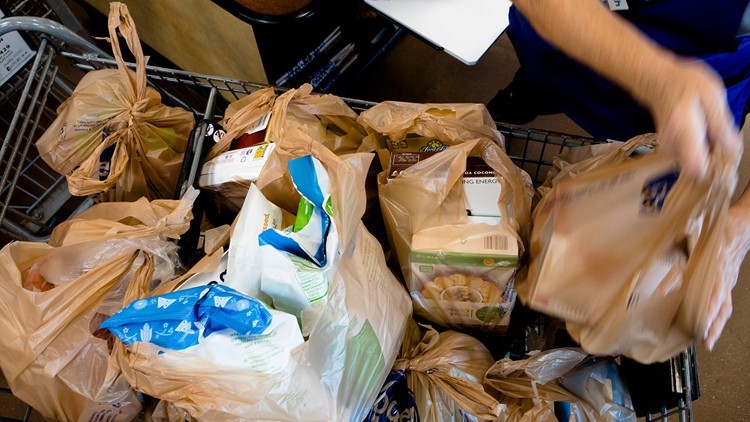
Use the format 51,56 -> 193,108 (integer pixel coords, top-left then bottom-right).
36,3 -> 194,201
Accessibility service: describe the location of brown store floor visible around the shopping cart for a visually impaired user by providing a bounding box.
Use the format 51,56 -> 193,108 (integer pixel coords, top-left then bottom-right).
0,30 -> 750,421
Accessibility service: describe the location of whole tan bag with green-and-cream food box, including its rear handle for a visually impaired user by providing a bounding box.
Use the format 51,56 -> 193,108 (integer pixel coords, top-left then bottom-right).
370,103 -> 533,334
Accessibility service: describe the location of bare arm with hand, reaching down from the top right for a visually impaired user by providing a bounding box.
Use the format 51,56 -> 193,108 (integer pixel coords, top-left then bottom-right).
513,0 -> 740,177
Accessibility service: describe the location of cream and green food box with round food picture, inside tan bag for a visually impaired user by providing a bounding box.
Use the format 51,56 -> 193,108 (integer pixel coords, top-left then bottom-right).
409,223 -> 519,333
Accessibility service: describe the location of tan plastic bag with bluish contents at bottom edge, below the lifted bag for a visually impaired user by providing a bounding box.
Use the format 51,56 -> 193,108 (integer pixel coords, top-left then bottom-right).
484,349 -> 636,422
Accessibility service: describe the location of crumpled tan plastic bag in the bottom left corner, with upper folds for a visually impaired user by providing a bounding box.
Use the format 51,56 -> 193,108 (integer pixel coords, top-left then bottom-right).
0,190 -> 198,421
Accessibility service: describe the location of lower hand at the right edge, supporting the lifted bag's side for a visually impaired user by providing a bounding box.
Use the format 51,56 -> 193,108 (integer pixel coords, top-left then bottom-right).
703,206 -> 750,350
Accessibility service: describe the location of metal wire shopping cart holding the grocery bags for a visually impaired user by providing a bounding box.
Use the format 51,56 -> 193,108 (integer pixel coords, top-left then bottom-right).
0,7 -> 698,421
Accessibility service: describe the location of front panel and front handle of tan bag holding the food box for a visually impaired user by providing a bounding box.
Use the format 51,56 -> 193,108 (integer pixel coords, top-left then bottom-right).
379,141 -> 530,333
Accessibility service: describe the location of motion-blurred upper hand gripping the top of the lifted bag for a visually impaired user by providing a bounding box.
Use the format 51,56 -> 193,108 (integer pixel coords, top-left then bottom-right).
642,58 -> 742,178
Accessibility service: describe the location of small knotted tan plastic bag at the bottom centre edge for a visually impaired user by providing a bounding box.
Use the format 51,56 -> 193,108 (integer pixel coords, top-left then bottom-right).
365,321 -> 499,422
